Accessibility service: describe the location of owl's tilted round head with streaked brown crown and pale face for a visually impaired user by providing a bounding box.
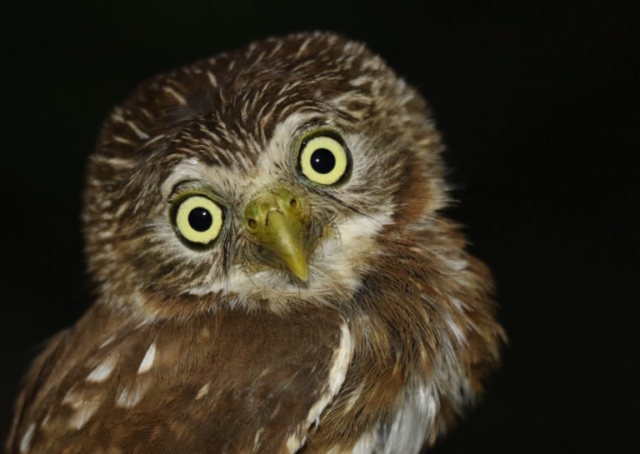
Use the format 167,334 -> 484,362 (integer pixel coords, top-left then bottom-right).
85,34 -> 444,312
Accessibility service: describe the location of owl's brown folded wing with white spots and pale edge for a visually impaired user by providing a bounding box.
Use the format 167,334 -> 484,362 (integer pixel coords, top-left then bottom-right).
9,309 -> 352,454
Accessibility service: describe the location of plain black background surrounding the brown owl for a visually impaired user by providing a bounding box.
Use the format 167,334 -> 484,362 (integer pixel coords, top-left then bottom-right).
0,0 -> 640,454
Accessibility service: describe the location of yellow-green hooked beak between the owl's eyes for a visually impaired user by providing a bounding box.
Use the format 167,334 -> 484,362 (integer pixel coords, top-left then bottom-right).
245,188 -> 309,282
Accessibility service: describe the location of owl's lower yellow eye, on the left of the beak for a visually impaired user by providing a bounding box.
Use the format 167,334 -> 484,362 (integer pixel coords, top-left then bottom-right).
171,194 -> 224,247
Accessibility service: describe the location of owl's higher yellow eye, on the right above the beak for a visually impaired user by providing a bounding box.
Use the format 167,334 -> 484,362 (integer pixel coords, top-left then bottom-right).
298,134 -> 350,186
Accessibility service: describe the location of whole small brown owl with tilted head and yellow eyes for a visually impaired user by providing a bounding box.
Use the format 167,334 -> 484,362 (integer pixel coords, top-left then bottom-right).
7,33 -> 505,454
